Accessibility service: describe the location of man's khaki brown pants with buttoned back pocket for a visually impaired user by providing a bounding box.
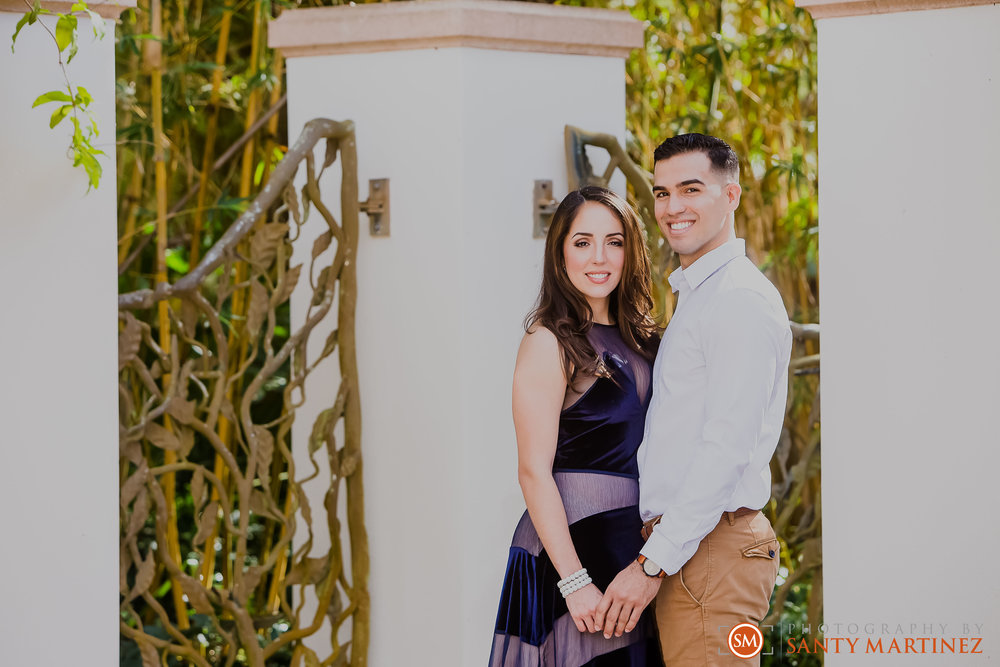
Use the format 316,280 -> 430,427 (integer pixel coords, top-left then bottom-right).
655,512 -> 778,667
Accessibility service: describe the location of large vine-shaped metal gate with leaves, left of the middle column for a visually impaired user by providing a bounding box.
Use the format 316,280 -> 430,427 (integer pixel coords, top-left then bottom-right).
119,119 -> 369,667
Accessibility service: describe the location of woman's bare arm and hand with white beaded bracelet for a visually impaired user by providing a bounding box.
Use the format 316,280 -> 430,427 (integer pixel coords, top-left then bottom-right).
512,327 -> 601,632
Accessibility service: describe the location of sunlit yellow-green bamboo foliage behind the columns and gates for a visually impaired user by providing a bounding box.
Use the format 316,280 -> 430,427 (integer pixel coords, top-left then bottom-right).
115,0 -> 822,664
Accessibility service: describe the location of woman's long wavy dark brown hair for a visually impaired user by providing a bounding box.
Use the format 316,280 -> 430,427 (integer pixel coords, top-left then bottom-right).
524,185 -> 658,385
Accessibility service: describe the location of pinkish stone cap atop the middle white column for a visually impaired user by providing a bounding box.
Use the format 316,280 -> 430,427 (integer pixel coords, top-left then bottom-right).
268,0 -> 643,58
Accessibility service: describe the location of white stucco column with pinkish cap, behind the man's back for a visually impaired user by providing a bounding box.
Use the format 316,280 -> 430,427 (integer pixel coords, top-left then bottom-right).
797,0 -> 1000,666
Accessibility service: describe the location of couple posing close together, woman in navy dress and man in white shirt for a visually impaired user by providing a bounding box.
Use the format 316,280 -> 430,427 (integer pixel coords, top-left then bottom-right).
490,134 -> 791,667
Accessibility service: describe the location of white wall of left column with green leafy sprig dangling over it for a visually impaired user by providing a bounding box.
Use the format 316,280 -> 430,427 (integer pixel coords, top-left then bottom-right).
0,7 -> 118,667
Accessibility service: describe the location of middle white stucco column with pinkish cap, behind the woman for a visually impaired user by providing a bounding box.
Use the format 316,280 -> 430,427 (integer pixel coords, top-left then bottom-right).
270,0 -> 642,667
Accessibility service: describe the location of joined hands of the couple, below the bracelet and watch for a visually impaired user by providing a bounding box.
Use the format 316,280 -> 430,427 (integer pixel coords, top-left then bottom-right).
566,561 -> 663,639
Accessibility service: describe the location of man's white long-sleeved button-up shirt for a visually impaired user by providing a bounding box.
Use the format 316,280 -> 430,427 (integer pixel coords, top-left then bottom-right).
639,239 -> 792,574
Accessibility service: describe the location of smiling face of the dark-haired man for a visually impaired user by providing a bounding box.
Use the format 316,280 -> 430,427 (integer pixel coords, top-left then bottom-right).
653,151 -> 741,268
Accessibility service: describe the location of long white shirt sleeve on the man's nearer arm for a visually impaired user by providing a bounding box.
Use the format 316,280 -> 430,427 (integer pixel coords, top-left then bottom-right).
641,288 -> 789,574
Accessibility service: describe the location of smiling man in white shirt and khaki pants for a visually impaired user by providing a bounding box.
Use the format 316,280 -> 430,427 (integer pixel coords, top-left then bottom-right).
596,134 -> 791,667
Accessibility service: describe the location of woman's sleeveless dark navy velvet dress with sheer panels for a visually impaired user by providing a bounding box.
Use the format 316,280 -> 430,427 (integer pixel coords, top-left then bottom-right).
489,324 -> 663,667
